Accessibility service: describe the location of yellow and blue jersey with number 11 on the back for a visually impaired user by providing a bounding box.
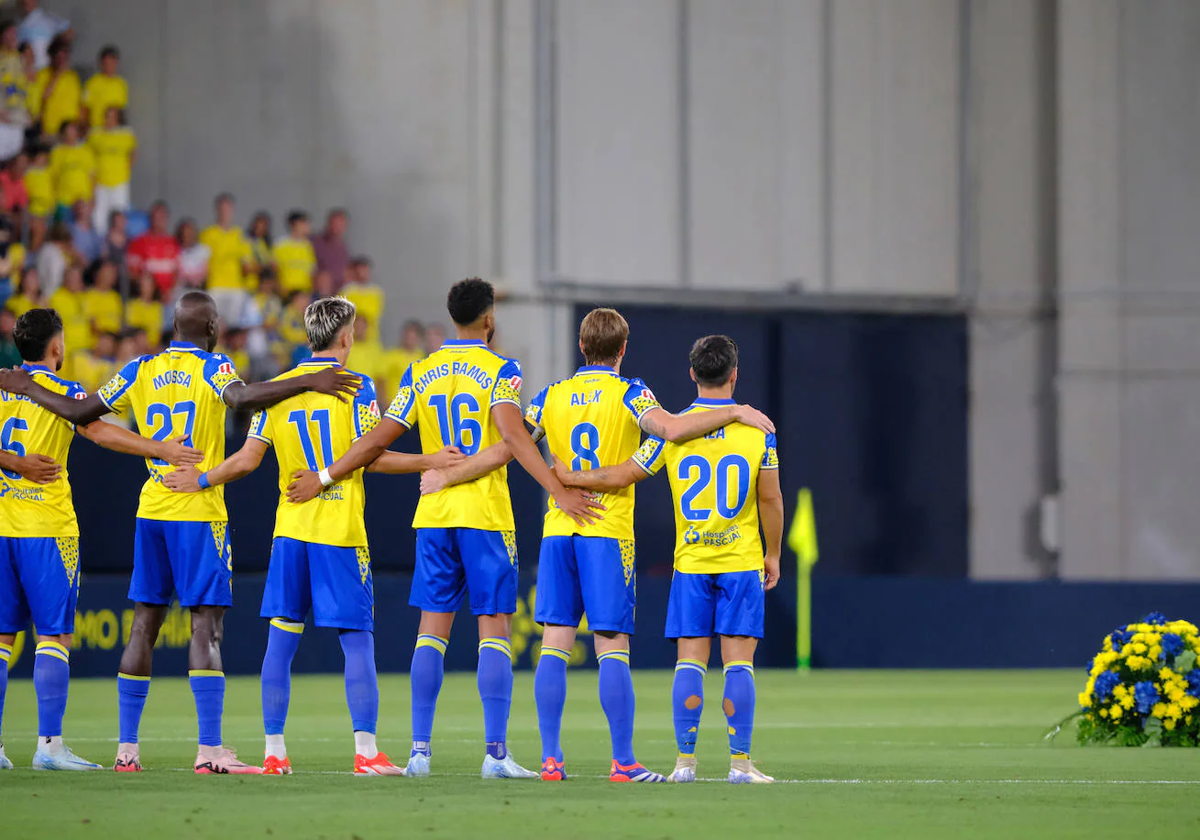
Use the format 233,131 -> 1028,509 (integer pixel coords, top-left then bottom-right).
248,356 -> 379,547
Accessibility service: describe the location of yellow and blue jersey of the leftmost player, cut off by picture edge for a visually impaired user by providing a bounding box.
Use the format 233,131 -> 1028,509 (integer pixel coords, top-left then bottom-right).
0,365 -> 88,536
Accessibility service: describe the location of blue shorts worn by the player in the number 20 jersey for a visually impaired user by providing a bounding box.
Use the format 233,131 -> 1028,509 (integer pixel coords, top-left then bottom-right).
662,571 -> 766,638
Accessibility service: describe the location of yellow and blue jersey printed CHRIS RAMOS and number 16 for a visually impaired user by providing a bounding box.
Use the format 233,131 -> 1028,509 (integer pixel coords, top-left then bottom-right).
384,340 -> 521,530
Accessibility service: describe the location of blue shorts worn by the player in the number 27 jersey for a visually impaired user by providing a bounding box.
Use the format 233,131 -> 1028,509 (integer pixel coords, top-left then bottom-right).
130,517 -> 233,607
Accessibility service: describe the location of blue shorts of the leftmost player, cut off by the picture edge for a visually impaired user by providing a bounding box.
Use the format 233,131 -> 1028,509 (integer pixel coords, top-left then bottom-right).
0,536 -> 79,636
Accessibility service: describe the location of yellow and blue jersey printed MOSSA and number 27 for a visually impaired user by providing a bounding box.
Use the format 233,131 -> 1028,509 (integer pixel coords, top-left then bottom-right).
100,341 -> 241,522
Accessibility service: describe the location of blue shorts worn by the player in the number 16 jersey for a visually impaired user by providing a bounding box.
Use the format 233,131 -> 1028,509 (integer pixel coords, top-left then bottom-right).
408,528 -> 517,616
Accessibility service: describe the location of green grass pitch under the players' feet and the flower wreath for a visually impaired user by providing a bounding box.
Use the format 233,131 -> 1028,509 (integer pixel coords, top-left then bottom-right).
0,668 -> 1200,840
